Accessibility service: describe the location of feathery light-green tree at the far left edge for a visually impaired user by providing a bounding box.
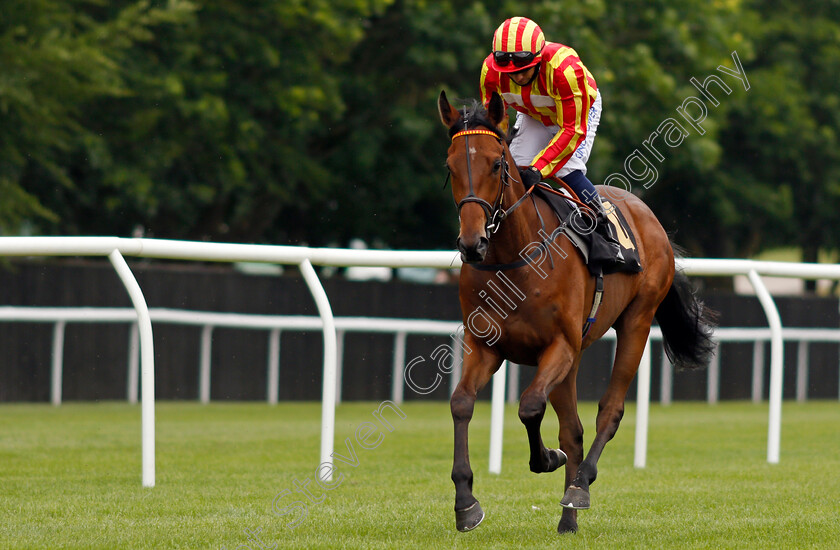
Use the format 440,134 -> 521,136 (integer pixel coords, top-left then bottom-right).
0,0 -> 194,233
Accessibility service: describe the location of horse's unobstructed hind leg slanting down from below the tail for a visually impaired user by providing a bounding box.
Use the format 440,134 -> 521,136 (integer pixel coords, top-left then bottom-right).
560,315 -> 653,510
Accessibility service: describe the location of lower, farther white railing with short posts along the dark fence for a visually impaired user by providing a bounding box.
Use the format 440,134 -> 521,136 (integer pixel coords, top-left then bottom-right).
0,306 -> 840,405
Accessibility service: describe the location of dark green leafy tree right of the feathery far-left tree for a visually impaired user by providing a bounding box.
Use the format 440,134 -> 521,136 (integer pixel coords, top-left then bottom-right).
12,0 -> 394,242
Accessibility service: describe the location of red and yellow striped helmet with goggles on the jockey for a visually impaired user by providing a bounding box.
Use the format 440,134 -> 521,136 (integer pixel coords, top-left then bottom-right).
490,17 -> 545,73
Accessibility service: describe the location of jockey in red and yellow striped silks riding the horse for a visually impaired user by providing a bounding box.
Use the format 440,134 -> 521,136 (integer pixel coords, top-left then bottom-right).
480,17 -> 621,257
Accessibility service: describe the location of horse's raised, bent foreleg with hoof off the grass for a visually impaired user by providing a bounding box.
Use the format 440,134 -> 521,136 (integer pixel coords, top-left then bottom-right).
519,342 -> 573,473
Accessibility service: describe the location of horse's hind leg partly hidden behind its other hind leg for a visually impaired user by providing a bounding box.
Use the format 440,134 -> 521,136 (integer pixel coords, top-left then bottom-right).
548,364 -> 583,534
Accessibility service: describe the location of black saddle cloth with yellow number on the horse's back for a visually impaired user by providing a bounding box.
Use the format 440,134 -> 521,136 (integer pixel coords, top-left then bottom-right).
532,182 -> 642,276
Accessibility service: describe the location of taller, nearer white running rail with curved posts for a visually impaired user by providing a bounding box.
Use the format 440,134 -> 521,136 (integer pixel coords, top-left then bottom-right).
0,237 -> 840,487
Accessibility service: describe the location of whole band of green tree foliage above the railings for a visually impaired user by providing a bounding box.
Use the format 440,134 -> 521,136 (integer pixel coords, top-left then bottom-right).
0,0 -> 840,260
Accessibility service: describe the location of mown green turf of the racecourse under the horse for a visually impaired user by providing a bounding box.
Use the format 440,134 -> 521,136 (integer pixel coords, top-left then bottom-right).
0,402 -> 840,550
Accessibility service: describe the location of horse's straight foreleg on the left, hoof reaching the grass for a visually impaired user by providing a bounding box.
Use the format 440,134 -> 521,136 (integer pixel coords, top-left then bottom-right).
449,344 -> 501,531
